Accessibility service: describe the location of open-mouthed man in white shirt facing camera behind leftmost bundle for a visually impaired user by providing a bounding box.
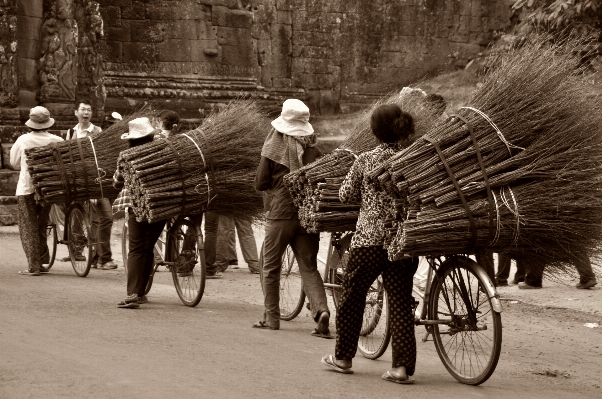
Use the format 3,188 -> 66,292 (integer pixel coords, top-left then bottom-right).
67,99 -> 117,270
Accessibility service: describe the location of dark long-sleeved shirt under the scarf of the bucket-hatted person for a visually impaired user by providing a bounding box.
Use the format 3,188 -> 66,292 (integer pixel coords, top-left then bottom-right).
255,147 -> 321,219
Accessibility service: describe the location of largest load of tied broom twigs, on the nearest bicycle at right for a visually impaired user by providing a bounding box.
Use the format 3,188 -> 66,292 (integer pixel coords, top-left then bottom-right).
369,36 -> 602,274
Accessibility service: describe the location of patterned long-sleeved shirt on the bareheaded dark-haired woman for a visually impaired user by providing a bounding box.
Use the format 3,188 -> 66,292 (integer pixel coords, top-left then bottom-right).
339,143 -> 400,248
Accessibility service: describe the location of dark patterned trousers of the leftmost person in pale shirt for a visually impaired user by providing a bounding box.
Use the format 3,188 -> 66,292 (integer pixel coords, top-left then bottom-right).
17,194 -> 50,271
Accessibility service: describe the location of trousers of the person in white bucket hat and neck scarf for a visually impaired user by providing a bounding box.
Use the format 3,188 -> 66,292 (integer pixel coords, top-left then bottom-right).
261,219 -> 330,327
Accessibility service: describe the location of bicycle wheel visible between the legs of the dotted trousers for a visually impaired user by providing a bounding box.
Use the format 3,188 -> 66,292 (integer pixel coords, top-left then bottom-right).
357,276 -> 391,360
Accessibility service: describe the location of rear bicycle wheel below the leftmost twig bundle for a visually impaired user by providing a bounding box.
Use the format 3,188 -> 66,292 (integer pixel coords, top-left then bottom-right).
66,204 -> 94,277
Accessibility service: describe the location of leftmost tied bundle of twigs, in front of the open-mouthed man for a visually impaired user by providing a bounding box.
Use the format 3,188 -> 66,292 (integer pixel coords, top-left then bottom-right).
25,107 -> 152,203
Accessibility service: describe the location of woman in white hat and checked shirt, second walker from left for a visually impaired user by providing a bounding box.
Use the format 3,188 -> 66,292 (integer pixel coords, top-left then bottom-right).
113,117 -> 166,309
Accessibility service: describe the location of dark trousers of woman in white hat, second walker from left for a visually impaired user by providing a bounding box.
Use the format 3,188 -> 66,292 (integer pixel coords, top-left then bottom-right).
127,213 -> 166,296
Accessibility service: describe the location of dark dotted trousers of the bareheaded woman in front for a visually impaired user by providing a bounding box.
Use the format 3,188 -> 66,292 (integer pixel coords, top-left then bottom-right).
335,246 -> 418,375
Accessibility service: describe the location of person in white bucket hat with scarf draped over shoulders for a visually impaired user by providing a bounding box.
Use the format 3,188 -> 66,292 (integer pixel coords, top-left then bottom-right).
253,99 -> 332,338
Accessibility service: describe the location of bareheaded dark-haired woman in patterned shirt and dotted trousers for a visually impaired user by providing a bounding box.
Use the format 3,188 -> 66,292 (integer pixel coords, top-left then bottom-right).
322,104 -> 418,384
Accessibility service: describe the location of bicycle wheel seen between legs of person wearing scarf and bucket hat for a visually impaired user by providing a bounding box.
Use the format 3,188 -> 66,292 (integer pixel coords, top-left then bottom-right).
278,245 -> 305,321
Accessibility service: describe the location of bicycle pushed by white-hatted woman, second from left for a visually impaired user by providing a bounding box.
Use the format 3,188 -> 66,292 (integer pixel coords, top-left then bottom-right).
121,209 -> 206,307
